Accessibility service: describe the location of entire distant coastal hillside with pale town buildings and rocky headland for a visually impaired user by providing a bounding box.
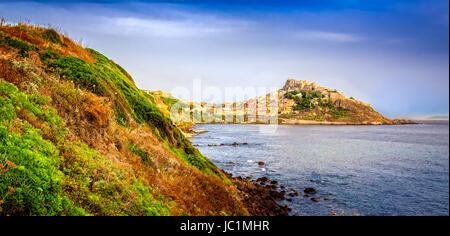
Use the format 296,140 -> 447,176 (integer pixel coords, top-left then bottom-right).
149,79 -> 414,127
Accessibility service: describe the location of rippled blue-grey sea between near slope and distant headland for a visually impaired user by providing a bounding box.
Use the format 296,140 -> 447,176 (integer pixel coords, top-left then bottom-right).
191,121 -> 449,216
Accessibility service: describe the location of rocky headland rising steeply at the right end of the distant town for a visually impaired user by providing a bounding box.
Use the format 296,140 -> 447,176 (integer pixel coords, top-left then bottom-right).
279,79 -> 400,125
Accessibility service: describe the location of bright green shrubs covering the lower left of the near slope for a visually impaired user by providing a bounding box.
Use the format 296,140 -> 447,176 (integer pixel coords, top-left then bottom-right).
0,82 -> 174,215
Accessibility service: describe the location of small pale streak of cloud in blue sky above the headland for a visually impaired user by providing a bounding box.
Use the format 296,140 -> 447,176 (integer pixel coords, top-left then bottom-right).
296,31 -> 364,43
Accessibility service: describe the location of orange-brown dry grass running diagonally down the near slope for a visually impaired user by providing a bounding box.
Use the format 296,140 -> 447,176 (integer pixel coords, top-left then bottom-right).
0,23 -> 248,215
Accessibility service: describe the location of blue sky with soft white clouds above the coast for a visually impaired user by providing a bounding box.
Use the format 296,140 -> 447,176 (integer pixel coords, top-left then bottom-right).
0,0 -> 449,118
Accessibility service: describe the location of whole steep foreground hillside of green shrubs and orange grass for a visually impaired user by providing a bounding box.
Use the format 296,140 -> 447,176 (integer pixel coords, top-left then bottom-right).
0,24 -> 248,215
